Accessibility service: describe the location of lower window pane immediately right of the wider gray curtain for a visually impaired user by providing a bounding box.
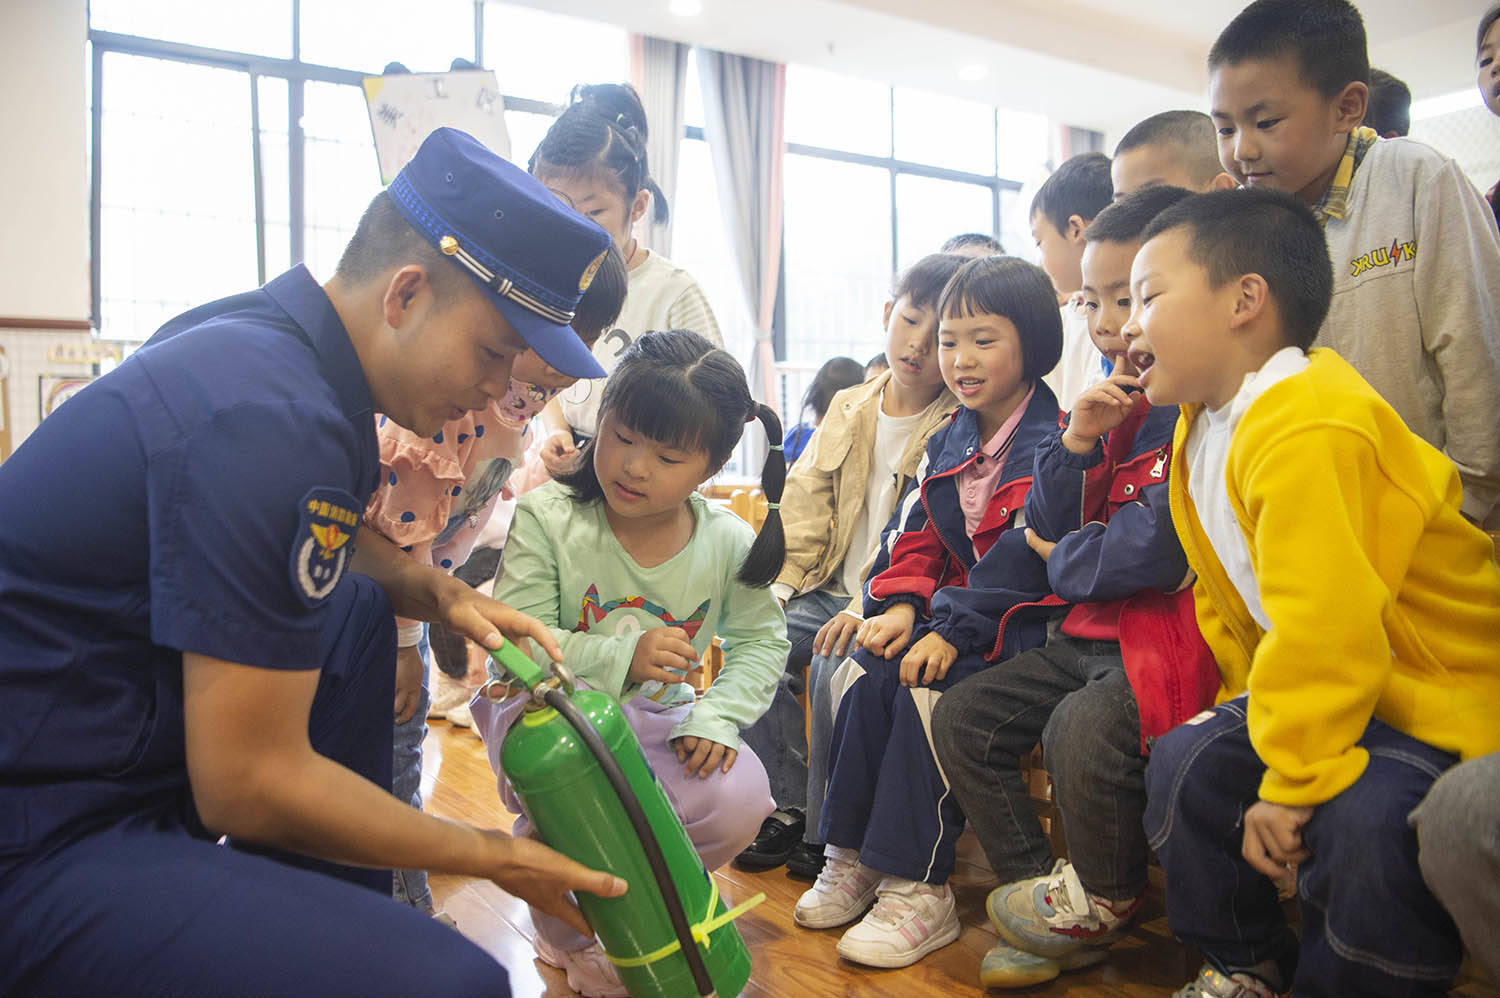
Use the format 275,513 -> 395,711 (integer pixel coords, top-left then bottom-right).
785,155 -> 891,371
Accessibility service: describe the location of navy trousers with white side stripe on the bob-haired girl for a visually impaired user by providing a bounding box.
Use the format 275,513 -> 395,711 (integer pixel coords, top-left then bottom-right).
819,642 -> 990,884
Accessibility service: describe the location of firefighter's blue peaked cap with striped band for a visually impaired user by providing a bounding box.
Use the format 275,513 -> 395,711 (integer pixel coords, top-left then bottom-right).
386,128 -> 609,378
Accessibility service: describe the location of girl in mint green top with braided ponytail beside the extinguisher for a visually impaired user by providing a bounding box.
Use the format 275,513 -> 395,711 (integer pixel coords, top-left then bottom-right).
471,330 -> 791,993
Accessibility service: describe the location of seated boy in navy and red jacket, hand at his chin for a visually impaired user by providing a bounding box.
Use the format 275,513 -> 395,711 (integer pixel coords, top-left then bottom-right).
933,186 -> 1218,987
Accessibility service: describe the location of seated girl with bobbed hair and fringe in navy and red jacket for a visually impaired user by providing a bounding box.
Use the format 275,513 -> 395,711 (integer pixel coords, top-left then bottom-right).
794,257 -> 1062,966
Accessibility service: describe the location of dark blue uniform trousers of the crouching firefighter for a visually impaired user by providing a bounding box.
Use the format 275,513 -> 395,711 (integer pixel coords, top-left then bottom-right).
0,575 -> 510,996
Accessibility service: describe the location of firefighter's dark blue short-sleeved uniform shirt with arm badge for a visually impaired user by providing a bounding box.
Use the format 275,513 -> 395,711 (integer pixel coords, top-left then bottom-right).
0,267 -> 380,858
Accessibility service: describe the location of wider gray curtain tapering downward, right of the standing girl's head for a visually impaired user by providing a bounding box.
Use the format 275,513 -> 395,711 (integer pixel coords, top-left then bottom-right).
698,48 -> 786,408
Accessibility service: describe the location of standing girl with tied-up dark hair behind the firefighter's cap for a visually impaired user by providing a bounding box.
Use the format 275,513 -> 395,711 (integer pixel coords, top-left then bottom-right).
528,83 -> 725,476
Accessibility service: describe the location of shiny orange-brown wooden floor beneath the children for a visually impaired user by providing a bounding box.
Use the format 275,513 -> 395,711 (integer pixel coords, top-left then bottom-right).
422,720 -> 1500,998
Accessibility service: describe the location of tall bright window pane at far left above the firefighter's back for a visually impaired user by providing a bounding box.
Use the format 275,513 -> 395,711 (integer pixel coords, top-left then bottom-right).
99,53 -> 258,339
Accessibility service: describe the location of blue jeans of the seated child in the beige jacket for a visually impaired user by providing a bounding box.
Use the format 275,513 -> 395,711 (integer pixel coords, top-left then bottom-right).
740,590 -> 849,810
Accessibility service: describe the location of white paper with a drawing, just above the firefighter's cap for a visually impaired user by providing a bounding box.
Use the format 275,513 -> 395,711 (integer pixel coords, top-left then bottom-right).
365,69 -> 510,183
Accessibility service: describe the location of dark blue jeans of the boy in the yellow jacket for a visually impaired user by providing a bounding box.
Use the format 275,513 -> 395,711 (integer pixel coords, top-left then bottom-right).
1146,696 -> 1461,998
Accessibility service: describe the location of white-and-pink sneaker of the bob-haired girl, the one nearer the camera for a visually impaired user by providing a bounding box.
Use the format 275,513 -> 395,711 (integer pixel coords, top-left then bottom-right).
839,876 -> 962,966
